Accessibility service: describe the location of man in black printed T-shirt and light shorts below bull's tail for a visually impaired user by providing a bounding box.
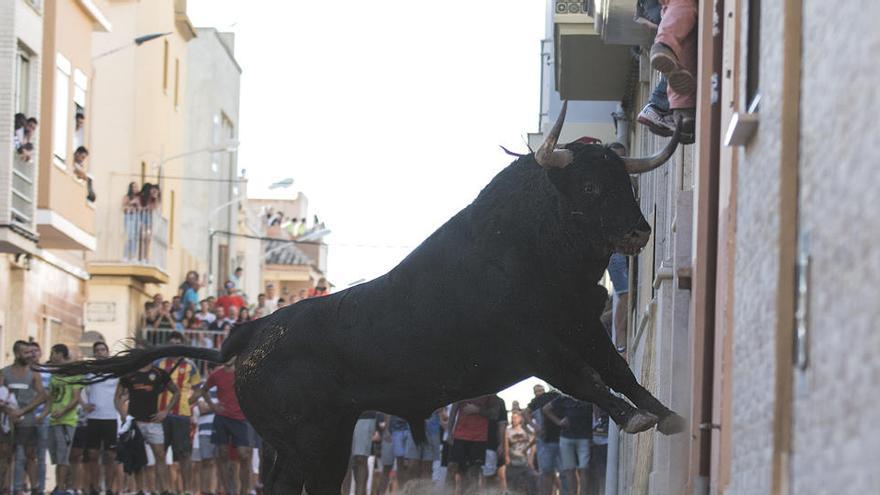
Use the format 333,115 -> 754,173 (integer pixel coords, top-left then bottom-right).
115,364 -> 180,493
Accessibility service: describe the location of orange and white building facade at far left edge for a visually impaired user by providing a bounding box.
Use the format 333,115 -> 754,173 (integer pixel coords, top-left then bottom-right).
0,0 -> 112,362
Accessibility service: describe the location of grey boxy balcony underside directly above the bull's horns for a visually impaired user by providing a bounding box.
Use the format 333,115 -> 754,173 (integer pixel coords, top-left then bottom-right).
553,0 -> 632,101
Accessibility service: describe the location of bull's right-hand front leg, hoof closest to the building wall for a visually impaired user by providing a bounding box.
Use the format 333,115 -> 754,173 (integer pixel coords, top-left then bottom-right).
587,338 -> 685,435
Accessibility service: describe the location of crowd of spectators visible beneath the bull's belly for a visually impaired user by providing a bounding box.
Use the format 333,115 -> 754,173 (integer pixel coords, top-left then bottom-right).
342,384 -> 608,495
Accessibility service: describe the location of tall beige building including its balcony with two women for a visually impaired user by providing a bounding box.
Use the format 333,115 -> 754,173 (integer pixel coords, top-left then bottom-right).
86,0 -> 195,348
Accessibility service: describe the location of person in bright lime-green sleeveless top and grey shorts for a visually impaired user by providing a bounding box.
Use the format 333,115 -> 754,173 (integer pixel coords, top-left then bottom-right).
43,344 -> 82,492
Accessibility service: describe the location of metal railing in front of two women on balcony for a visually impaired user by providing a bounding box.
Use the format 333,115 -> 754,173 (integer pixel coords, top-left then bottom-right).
122,208 -> 168,270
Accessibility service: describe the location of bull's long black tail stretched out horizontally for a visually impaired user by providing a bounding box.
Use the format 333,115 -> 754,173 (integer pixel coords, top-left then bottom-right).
36,322 -> 254,383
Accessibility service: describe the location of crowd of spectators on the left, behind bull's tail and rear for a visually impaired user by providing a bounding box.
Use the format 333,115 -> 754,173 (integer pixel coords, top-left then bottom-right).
0,268 -> 327,495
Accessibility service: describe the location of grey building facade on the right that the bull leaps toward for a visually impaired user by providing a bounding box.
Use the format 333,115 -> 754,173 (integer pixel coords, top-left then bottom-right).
536,0 -> 880,494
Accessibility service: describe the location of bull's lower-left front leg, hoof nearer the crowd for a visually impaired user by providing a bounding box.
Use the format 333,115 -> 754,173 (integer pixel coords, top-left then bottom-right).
535,349 -> 658,433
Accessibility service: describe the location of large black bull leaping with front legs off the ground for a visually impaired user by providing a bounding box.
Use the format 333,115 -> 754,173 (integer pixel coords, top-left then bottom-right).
43,110 -> 682,494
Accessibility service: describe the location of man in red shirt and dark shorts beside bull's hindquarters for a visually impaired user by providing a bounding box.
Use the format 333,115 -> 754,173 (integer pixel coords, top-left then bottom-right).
194,359 -> 254,493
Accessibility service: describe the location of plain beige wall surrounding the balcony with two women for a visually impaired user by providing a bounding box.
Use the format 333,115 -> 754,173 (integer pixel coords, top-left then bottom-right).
87,0 -> 197,348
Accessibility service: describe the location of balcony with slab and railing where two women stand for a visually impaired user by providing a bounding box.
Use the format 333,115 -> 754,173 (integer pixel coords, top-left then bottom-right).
89,208 -> 169,284
